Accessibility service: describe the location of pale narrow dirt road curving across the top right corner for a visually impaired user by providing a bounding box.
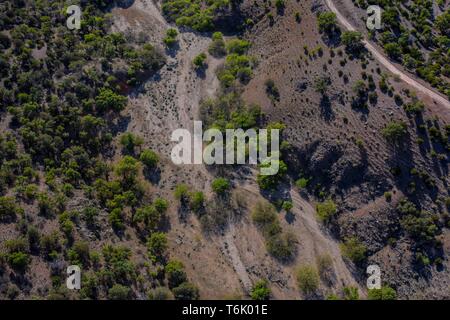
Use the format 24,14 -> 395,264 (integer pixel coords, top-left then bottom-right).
325,0 -> 450,109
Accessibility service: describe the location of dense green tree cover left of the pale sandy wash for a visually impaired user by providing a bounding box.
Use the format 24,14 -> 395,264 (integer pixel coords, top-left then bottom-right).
0,0 -> 192,299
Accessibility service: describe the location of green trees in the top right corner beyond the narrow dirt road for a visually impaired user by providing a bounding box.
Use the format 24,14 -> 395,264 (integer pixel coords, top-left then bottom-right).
357,0 -> 450,98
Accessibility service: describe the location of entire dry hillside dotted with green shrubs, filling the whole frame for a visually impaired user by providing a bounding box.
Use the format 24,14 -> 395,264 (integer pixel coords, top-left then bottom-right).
0,0 -> 450,300
